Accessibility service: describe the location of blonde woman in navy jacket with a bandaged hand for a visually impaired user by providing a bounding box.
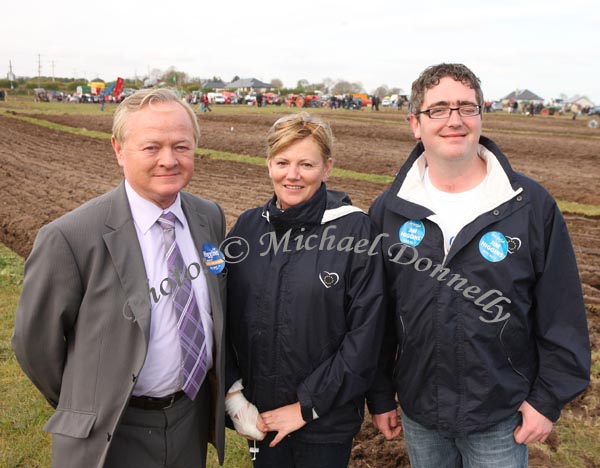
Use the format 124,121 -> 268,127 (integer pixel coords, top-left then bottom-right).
226,112 -> 384,468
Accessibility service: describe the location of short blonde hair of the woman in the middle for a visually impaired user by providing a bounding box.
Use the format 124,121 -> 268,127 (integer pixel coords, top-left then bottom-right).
267,112 -> 334,162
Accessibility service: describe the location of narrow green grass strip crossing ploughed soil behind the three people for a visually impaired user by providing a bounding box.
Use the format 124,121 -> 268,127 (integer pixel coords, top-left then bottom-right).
0,109 -> 600,216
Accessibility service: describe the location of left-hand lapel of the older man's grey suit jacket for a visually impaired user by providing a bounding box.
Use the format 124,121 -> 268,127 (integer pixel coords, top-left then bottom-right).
103,183 -> 150,342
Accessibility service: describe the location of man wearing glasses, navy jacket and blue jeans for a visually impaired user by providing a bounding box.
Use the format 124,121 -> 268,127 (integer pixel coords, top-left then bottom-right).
367,64 -> 590,468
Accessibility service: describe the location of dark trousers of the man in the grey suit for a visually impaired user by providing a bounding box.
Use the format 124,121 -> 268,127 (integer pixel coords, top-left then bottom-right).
104,382 -> 210,468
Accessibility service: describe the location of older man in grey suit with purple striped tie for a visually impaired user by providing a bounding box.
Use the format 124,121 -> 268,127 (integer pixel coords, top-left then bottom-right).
12,90 -> 225,468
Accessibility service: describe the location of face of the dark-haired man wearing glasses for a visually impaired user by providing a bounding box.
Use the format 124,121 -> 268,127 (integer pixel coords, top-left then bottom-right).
410,77 -> 481,165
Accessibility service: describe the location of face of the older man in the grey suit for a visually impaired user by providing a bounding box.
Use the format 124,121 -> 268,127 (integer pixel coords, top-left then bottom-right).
112,102 -> 195,208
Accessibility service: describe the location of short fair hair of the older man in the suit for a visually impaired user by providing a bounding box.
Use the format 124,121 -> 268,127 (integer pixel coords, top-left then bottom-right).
112,88 -> 200,146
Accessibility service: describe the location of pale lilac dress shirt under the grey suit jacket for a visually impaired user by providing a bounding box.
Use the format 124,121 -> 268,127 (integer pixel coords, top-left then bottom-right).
125,181 -> 214,397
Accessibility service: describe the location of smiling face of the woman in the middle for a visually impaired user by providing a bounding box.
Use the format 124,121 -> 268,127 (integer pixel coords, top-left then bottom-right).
267,137 -> 332,210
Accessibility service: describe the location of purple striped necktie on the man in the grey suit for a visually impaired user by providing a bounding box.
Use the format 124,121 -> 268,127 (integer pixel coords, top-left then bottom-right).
157,211 -> 207,400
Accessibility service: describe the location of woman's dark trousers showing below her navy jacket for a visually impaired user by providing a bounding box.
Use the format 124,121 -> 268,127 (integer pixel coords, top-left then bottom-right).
249,432 -> 352,468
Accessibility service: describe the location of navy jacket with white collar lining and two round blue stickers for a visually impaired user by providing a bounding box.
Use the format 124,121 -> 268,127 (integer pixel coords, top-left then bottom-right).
367,137 -> 591,436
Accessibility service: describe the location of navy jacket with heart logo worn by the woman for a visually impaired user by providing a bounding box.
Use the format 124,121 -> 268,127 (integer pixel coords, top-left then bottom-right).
225,184 -> 385,443
